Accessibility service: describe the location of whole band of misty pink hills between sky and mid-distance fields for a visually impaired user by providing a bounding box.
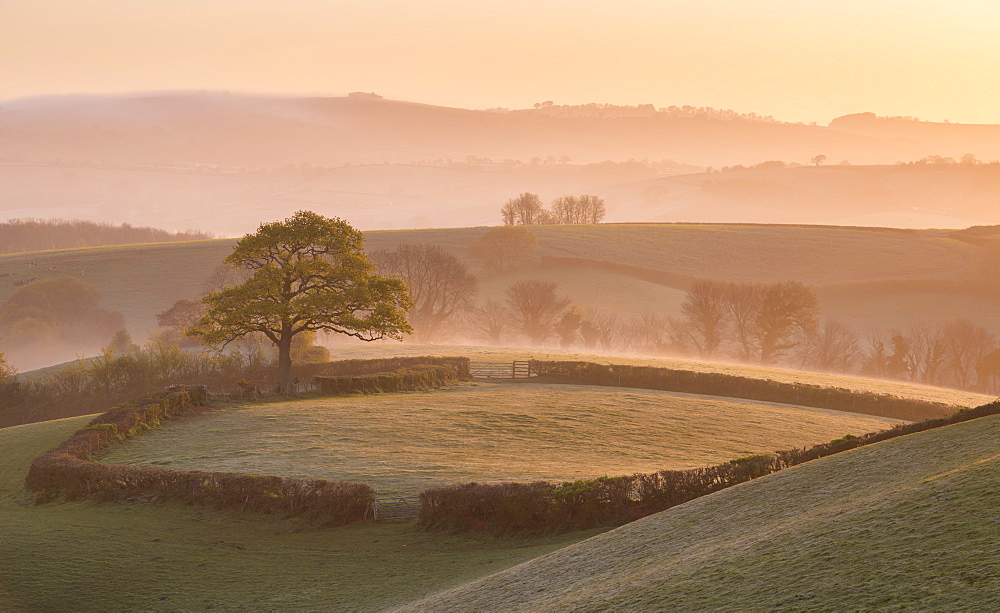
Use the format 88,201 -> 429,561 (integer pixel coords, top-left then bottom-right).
0,92 -> 1000,236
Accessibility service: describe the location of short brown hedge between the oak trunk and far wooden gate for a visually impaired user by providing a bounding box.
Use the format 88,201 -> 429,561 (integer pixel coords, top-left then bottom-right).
314,358 -> 471,394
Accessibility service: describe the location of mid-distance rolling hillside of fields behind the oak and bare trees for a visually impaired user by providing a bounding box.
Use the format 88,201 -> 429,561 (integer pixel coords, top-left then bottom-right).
0,224 -> 1000,369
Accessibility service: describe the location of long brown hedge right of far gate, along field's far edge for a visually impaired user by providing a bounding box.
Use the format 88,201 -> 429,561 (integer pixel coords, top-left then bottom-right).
532,361 -> 958,421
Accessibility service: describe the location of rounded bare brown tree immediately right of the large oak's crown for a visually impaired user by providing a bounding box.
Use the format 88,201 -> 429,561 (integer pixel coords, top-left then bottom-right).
370,244 -> 478,342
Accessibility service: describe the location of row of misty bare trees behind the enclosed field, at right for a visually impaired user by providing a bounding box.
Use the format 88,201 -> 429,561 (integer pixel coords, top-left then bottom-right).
451,280 -> 1000,391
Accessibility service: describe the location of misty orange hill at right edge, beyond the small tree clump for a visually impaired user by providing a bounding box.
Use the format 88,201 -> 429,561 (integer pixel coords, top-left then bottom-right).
603,161 -> 1000,228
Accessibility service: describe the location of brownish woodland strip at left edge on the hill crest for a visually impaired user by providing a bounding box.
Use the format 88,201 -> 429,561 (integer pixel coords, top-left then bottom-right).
0,219 -> 215,253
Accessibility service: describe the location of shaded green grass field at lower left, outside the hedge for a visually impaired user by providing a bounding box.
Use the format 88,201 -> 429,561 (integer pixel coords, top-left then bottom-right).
0,417 -> 594,613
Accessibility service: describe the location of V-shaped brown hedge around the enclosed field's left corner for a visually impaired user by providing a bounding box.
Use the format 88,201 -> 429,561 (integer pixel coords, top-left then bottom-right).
25,386 -> 375,525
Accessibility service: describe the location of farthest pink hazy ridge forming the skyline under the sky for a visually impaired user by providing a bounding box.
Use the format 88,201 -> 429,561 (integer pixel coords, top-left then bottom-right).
0,92 -> 908,168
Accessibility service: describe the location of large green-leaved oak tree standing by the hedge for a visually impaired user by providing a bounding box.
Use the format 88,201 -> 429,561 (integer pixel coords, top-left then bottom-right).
190,211 -> 413,390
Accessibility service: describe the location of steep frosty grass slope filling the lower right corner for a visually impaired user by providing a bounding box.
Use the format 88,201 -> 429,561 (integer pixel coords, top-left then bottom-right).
403,408 -> 1000,611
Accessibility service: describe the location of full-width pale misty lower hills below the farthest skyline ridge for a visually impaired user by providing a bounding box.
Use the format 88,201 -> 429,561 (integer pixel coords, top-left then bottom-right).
0,161 -> 1000,236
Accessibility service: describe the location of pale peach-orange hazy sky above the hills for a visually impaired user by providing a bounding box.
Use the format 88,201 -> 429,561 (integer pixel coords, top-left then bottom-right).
0,0 -> 1000,123
